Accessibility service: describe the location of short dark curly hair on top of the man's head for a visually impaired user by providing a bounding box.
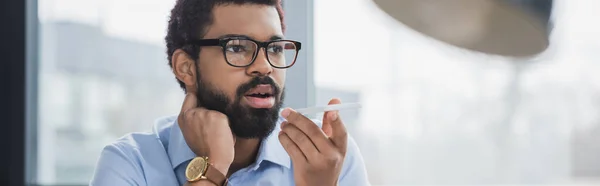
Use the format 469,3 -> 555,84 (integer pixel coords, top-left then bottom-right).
165,0 -> 285,91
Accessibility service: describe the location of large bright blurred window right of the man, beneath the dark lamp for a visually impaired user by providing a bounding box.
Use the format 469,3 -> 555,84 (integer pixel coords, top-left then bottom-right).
314,0 -> 600,185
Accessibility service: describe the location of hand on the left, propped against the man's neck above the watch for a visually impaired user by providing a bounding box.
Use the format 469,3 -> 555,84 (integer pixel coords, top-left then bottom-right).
177,92 -> 235,175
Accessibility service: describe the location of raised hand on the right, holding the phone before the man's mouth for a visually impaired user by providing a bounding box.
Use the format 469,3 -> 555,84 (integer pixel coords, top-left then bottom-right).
279,99 -> 348,186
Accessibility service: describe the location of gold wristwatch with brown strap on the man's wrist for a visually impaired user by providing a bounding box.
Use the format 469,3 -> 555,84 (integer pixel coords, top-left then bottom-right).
185,157 -> 227,186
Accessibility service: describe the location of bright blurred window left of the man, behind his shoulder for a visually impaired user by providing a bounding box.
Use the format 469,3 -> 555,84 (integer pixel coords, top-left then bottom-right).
34,0 -> 183,185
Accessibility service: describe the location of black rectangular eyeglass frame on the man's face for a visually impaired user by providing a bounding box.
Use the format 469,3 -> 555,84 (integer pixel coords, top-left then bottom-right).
191,36 -> 302,69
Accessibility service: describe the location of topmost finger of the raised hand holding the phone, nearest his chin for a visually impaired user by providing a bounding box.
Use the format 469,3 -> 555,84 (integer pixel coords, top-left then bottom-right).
281,108 -> 333,152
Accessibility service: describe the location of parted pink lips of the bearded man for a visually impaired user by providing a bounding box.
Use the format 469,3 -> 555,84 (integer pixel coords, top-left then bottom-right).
244,84 -> 275,108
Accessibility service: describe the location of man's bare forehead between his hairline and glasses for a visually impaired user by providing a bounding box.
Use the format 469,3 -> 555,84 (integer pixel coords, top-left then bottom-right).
204,4 -> 283,41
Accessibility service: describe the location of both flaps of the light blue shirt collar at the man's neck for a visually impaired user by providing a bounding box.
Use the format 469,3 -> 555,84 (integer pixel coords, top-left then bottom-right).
167,116 -> 291,170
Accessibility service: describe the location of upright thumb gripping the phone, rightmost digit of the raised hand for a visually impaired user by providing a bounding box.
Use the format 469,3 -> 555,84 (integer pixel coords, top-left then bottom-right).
323,99 -> 348,153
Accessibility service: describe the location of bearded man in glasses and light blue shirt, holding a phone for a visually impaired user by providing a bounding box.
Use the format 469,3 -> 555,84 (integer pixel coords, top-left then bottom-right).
91,0 -> 369,186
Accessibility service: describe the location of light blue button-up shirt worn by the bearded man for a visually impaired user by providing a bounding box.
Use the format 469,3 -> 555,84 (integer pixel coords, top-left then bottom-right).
90,116 -> 370,186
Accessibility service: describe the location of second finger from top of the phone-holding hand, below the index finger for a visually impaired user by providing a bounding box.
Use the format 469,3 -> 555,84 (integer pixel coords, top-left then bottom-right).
281,122 -> 319,160
